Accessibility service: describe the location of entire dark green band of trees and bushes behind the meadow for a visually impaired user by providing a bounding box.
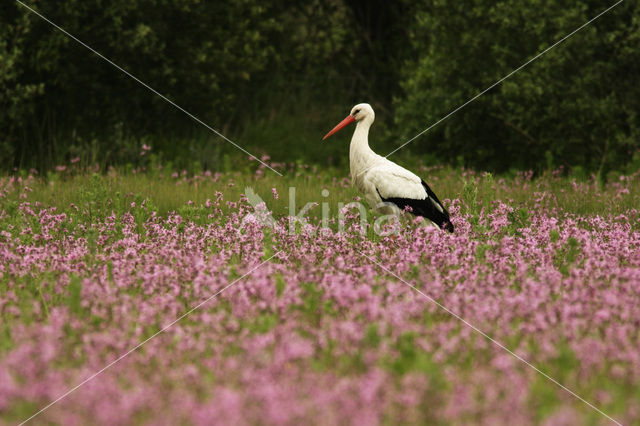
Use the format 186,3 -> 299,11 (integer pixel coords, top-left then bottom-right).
0,0 -> 640,177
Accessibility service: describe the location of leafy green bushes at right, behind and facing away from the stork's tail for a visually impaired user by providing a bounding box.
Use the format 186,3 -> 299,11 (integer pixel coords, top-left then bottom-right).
396,0 -> 640,176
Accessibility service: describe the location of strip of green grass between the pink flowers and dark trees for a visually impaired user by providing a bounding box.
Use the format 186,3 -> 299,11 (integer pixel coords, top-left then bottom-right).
5,166 -> 640,223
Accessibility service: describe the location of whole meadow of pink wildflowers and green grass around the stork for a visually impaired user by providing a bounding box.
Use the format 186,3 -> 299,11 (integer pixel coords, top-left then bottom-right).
0,159 -> 640,425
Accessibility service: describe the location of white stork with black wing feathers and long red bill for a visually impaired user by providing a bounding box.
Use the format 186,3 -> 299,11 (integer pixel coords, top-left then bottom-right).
322,103 -> 454,232
